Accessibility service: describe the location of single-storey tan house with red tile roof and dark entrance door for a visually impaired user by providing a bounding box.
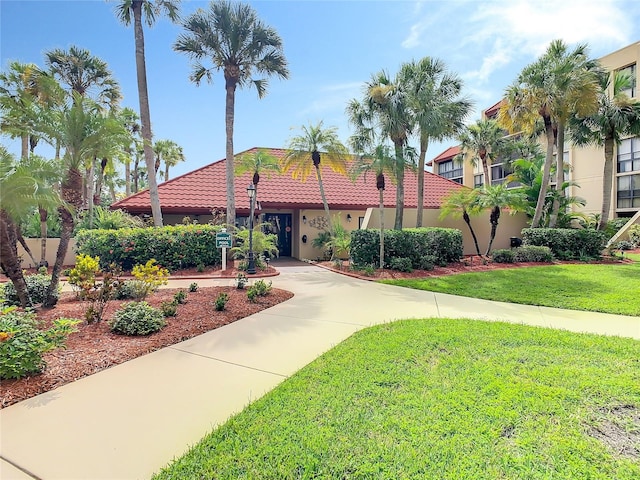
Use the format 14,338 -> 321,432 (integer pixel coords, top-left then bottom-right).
111,148 -> 526,259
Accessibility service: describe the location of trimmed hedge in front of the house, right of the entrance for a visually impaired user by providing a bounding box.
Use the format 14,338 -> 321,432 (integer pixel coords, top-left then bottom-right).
351,227 -> 463,269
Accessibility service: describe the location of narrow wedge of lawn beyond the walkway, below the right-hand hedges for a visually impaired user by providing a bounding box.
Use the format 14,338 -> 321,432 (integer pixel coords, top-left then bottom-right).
382,263 -> 640,316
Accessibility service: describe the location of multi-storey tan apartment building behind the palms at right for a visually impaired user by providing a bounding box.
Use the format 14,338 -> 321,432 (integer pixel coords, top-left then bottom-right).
429,42 -> 640,225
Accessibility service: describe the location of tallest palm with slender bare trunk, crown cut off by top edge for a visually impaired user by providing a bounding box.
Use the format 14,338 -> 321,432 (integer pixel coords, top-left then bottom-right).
116,0 -> 180,227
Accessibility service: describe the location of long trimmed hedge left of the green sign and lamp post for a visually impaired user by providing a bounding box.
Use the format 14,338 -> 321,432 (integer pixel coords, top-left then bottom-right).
76,225 -> 222,271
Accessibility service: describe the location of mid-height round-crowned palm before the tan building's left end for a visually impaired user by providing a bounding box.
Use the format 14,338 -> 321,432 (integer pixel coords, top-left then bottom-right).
458,119 -> 505,187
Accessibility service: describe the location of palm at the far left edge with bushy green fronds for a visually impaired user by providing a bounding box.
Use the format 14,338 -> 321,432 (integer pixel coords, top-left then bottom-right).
0,146 -> 60,307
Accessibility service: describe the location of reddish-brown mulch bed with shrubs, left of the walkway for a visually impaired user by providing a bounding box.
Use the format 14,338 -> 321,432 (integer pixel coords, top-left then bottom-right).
0,284 -> 293,408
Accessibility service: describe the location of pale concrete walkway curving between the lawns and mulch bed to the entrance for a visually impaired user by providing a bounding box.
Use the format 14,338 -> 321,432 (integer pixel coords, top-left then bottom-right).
0,262 -> 640,480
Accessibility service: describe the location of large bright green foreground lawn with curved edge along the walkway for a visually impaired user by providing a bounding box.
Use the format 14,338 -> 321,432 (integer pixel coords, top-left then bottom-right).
154,319 -> 640,480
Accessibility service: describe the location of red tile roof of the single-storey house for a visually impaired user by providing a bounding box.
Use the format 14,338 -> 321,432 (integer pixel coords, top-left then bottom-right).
111,148 -> 463,214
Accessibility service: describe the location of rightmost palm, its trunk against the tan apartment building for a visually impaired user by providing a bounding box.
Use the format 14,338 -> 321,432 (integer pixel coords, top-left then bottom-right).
570,71 -> 640,230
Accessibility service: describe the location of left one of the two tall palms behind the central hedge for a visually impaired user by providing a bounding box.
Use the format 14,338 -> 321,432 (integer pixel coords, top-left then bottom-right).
347,70 -> 415,230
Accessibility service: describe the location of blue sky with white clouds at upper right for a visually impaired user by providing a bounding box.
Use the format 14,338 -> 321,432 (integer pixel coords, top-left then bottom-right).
0,0 -> 640,177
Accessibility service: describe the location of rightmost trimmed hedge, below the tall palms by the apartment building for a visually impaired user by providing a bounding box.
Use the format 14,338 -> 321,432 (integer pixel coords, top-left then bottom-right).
522,228 -> 607,260
